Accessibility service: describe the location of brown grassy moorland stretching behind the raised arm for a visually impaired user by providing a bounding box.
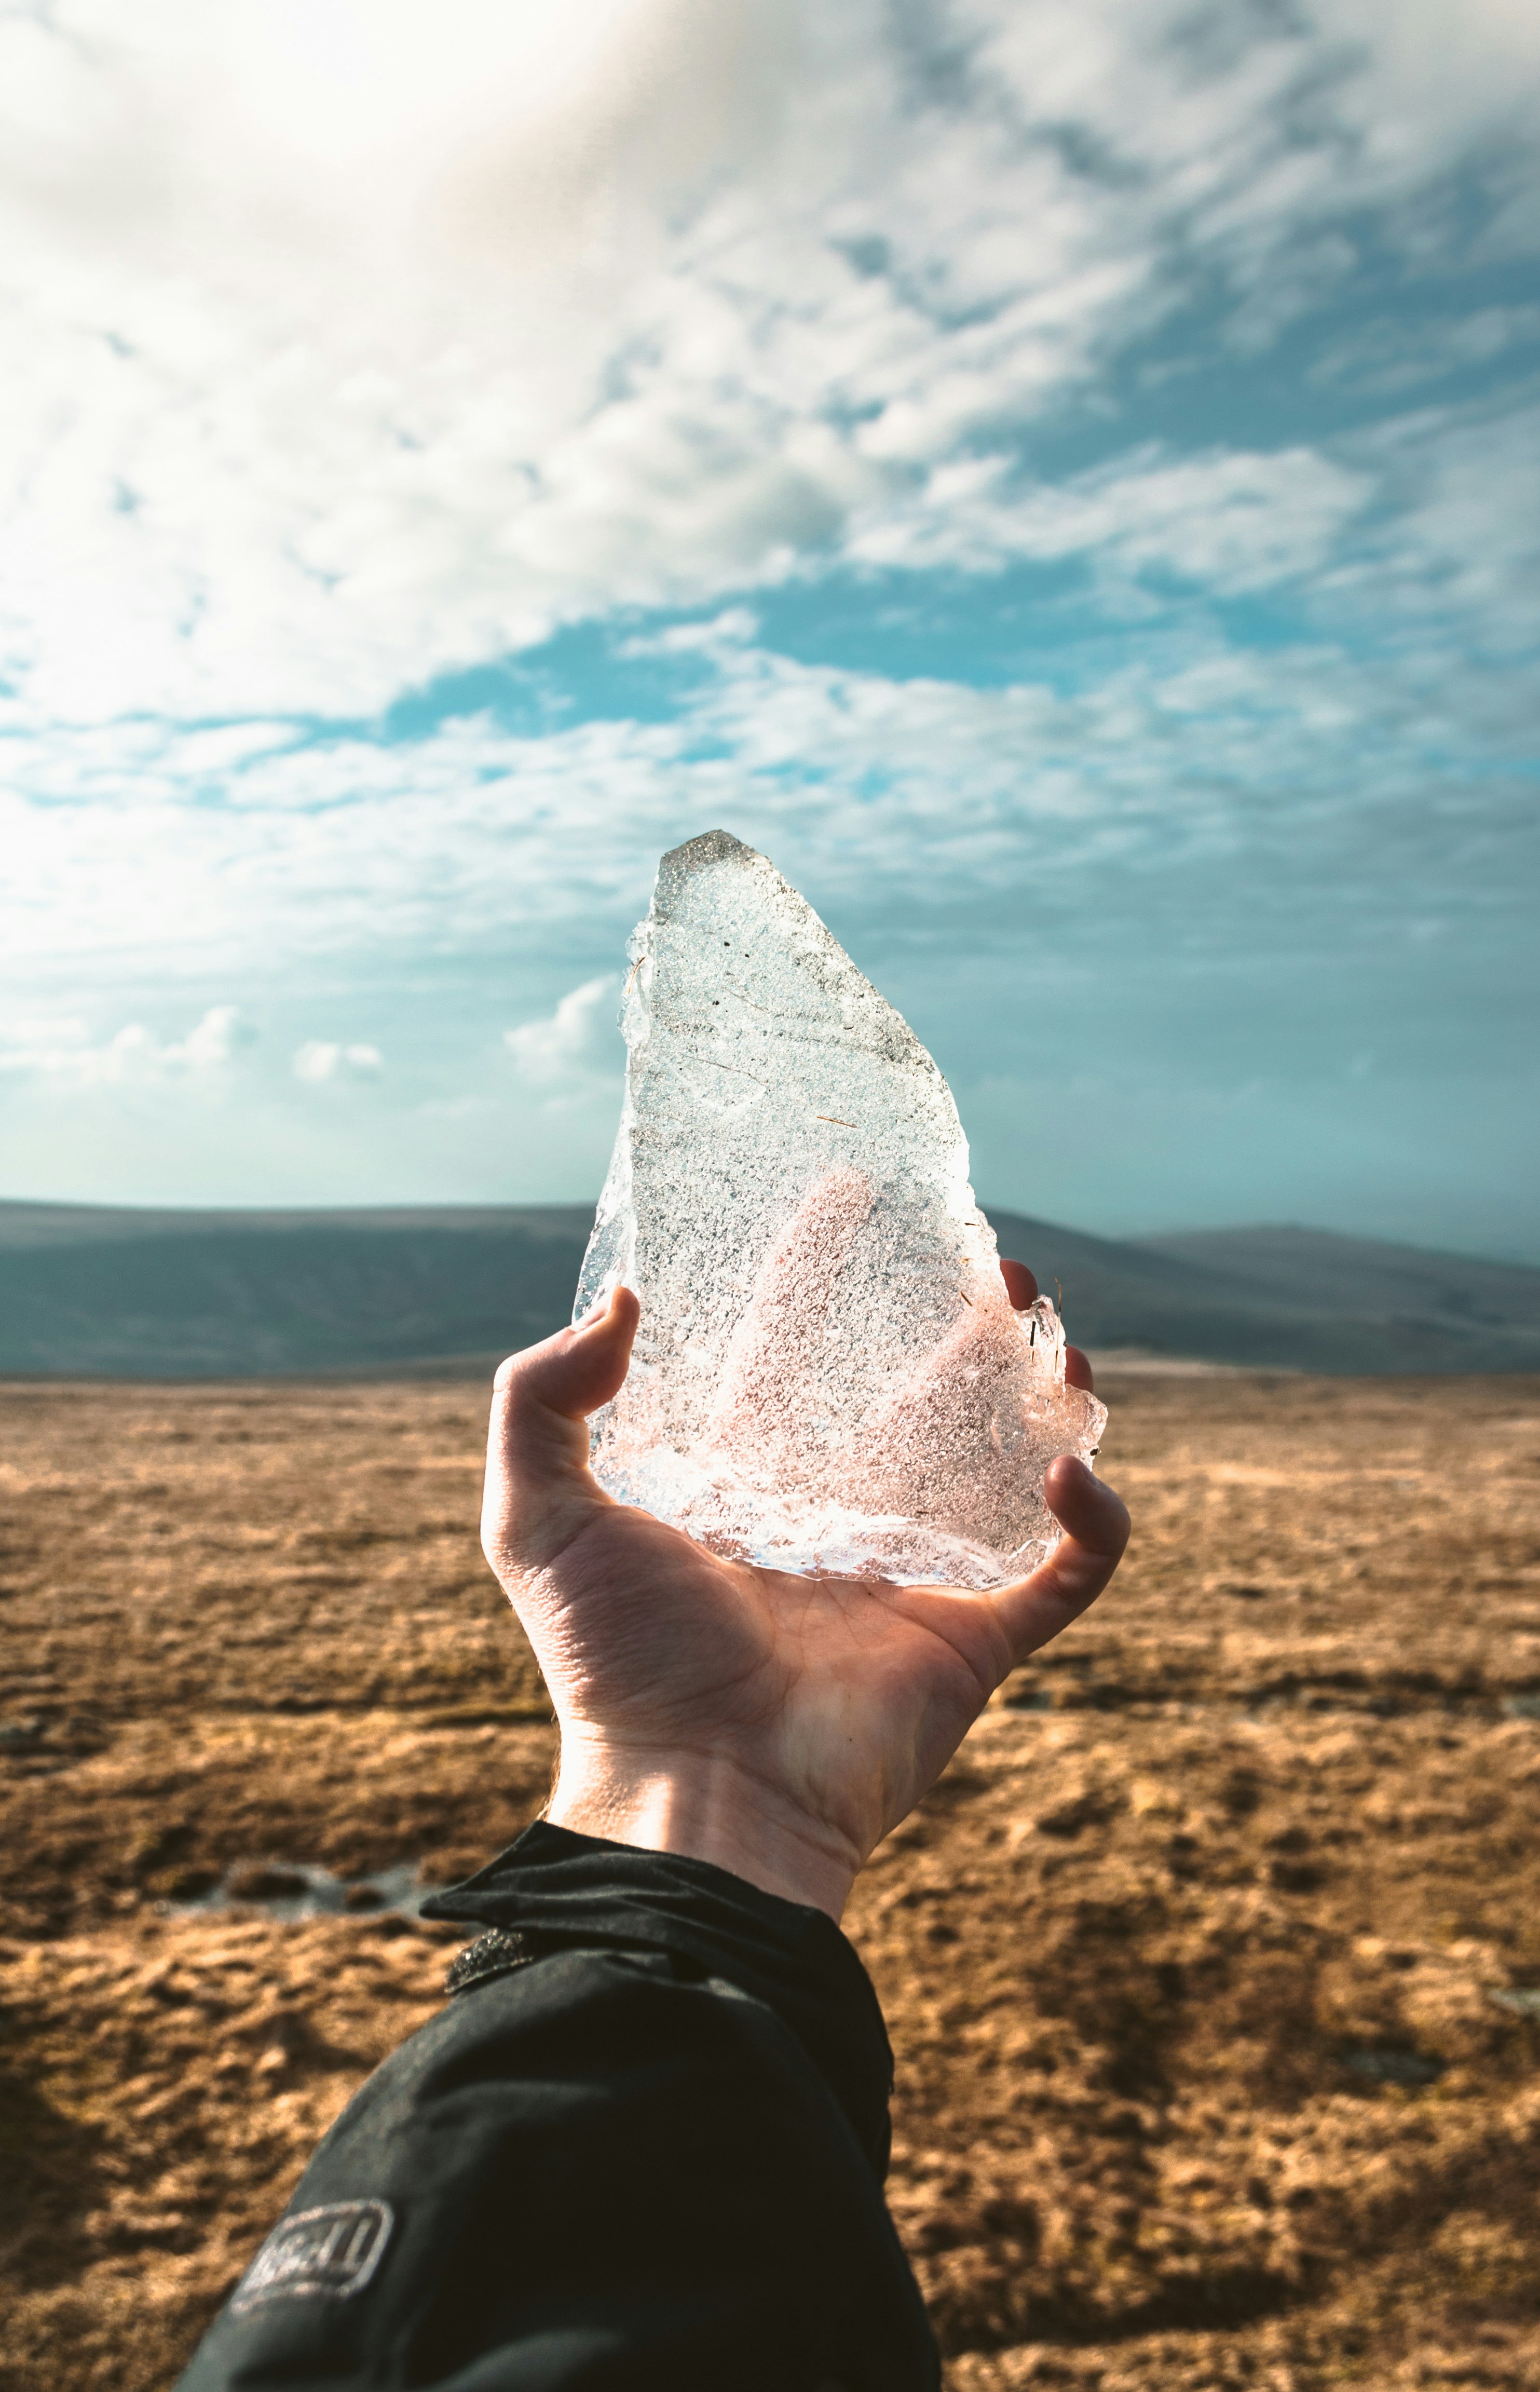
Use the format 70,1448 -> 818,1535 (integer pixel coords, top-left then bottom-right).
0,1373 -> 1540,2392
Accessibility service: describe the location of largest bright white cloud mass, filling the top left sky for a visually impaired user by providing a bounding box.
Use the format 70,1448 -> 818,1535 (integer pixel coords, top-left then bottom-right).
0,0 -> 1537,727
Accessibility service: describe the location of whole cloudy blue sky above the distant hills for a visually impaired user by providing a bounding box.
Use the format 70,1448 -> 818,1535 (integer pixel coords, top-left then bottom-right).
0,0 -> 1540,1263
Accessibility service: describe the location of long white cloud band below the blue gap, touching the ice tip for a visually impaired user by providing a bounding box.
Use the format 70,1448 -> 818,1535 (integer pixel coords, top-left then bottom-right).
0,564 -> 1531,1024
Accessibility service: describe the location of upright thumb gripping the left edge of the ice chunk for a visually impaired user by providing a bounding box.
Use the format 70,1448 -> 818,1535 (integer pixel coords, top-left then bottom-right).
481,1287 -> 641,1579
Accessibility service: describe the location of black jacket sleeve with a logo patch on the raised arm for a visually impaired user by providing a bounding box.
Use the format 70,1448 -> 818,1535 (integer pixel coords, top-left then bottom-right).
180,1825 -> 940,2392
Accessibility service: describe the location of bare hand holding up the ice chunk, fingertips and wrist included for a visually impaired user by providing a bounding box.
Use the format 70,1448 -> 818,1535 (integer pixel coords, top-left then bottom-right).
481,1263 -> 1129,1919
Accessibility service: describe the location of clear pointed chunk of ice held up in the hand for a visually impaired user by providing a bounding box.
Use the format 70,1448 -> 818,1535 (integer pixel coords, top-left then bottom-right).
574,830 -> 1107,1586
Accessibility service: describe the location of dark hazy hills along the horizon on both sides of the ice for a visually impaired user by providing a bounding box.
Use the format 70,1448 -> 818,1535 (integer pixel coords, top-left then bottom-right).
0,1203 -> 1540,1378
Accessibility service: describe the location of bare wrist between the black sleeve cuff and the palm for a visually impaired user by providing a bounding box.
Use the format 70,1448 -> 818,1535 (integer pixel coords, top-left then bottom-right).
545,1727 -> 861,1921
